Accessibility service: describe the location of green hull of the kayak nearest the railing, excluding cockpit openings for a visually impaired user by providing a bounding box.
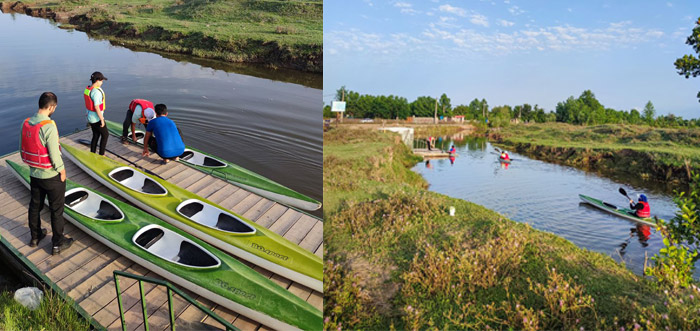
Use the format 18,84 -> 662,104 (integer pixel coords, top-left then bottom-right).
7,161 -> 322,329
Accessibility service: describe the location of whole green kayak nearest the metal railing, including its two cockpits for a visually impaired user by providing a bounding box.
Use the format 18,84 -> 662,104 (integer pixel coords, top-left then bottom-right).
7,161 -> 322,329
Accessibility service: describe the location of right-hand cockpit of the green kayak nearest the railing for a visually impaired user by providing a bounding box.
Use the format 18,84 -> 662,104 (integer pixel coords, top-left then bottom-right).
132,224 -> 221,269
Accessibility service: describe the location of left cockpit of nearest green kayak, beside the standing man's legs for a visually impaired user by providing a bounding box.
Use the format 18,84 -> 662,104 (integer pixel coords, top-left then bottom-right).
64,188 -> 124,222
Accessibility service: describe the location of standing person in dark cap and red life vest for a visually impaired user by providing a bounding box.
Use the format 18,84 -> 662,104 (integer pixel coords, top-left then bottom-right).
83,71 -> 109,155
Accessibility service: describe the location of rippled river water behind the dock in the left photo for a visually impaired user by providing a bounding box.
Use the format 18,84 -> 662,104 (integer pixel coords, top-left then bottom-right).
0,14 -> 323,213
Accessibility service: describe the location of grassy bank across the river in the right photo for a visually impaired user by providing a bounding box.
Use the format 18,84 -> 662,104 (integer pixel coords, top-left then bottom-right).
490,123 -> 700,187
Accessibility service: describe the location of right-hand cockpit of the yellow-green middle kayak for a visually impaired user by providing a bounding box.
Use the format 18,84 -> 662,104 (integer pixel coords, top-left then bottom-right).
177,199 -> 255,235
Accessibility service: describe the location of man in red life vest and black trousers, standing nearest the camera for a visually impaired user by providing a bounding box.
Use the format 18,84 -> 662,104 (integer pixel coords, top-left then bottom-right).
20,92 -> 73,255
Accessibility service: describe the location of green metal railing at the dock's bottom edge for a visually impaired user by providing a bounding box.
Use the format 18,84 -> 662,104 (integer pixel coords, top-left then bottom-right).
114,270 -> 238,331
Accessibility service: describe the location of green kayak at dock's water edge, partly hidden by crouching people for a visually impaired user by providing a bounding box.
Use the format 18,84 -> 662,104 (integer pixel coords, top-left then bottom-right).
105,121 -> 321,210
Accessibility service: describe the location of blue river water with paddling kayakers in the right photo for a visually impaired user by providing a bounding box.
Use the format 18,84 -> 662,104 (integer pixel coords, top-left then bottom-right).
413,135 -> 699,278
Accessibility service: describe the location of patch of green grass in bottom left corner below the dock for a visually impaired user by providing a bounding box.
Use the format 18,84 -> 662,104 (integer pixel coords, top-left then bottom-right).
0,292 -> 90,331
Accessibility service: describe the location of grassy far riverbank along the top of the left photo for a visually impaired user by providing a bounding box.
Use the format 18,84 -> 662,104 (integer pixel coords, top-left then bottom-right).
2,0 -> 323,73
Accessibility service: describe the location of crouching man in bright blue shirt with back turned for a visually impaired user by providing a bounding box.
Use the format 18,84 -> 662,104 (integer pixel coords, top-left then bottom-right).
143,103 -> 185,164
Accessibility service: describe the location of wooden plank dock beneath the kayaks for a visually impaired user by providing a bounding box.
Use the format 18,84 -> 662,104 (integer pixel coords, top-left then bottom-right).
0,130 -> 323,330
